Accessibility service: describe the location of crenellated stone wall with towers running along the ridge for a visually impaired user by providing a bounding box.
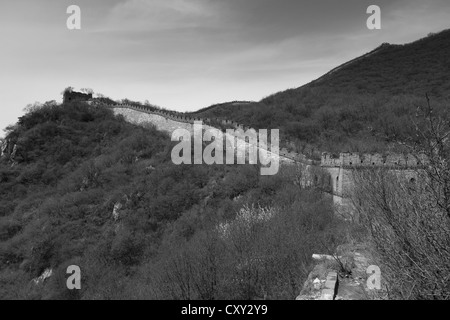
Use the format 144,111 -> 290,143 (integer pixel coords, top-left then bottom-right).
1,92 -> 424,218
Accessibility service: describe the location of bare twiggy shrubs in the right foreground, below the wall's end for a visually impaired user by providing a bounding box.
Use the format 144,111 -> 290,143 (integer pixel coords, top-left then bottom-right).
355,98 -> 450,300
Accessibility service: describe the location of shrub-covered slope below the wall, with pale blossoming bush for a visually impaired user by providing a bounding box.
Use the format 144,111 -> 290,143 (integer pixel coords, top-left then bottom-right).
0,102 -> 341,300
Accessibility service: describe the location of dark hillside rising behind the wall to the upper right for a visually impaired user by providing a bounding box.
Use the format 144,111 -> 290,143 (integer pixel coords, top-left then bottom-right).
194,30 -> 450,156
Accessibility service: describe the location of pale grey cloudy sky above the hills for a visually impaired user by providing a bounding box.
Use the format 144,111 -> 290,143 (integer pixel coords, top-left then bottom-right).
0,0 -> 450,136
